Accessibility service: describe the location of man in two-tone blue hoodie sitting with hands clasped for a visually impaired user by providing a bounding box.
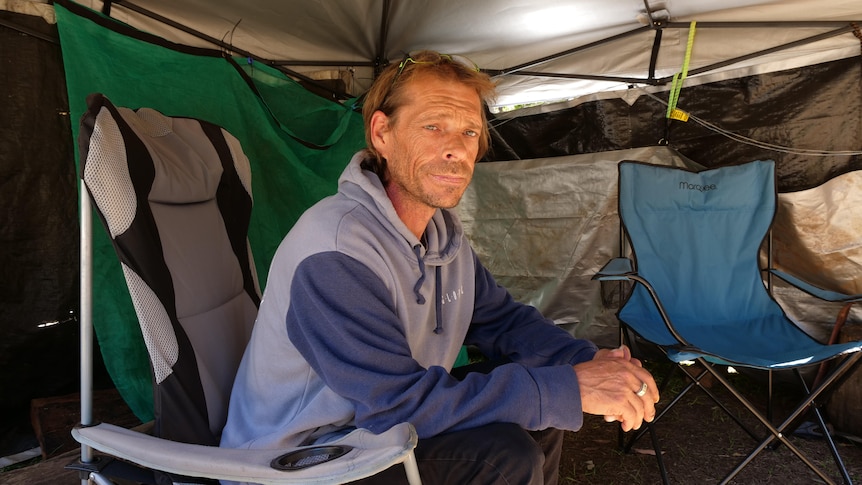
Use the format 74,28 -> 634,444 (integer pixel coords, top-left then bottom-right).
222,51 -> 658,484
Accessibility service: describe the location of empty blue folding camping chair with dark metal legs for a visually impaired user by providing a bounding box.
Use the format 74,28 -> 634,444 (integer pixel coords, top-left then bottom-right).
594,161 -> 862,483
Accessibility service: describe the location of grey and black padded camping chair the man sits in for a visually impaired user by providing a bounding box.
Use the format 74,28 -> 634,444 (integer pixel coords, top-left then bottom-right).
70,95 -> 420,484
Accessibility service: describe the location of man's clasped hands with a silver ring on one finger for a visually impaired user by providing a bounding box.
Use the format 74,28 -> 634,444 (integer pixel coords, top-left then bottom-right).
574,345 -> 659,431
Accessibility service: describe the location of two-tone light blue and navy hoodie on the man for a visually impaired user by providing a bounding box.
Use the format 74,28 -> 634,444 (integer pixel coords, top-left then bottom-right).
222,152 -> 596,448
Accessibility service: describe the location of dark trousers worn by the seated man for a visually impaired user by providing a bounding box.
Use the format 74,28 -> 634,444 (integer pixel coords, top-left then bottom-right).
353,423 -> 563,485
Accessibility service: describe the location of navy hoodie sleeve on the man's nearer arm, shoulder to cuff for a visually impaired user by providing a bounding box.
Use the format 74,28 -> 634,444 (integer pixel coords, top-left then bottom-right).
286,252 -> 583,438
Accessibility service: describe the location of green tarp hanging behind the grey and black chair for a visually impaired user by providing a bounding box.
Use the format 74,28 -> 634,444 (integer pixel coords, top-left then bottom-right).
56,2 -> 364,421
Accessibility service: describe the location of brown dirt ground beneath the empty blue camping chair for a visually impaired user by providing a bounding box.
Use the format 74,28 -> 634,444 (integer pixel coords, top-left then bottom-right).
560,363 -> 862,485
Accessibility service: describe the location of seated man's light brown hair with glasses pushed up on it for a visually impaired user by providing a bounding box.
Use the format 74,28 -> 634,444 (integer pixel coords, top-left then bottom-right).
362,50 -> 496,185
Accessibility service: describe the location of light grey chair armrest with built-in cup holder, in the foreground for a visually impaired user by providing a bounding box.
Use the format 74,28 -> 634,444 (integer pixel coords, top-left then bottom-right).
72,423 -> 418,484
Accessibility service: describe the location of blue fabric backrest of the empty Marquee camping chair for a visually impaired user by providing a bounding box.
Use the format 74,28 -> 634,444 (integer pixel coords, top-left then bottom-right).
619,161 -> 786,348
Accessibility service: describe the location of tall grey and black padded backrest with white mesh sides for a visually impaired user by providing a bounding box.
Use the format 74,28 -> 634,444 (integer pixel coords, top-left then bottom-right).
79,95 -> 260,445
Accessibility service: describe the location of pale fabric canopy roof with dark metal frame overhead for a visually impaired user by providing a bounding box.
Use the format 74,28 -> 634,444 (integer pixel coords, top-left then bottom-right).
60,0 -> 862,107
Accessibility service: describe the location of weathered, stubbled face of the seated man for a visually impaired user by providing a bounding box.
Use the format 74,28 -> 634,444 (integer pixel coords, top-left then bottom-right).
375,75 -> 490,210
